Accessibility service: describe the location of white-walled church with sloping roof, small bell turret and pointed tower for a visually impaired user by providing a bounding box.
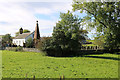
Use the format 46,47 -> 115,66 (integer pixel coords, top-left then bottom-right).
12,21 -> 40,46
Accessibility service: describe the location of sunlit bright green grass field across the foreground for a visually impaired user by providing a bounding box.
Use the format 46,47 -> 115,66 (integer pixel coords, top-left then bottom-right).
2,51 -> 118,78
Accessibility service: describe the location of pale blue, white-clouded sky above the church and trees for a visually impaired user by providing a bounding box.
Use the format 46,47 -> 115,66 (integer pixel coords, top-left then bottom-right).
0,0 -> 95,38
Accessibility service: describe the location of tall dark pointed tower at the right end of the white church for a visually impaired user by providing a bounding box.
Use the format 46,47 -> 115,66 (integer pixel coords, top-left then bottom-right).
34,21 -> 40,46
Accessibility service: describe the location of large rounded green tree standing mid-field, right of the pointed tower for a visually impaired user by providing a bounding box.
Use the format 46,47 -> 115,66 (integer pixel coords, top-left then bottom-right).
42,11 -> 87,56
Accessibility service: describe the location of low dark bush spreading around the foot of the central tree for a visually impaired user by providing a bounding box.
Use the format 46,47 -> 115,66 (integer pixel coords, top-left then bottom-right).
42,39 -> 80,57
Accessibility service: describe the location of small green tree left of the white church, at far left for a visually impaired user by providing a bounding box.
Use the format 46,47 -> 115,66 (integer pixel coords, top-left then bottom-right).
2,34 -> 12,47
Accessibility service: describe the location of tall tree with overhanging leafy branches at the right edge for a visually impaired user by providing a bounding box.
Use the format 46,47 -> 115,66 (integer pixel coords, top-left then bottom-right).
72,0 -> 120,49
